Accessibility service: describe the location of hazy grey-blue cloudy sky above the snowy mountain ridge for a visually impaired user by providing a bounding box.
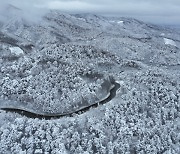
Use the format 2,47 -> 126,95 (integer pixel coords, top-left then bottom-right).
0,0 -> 180,25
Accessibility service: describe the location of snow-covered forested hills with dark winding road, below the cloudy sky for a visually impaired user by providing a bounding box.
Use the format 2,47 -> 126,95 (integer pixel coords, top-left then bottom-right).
0,8 -> 180,154
